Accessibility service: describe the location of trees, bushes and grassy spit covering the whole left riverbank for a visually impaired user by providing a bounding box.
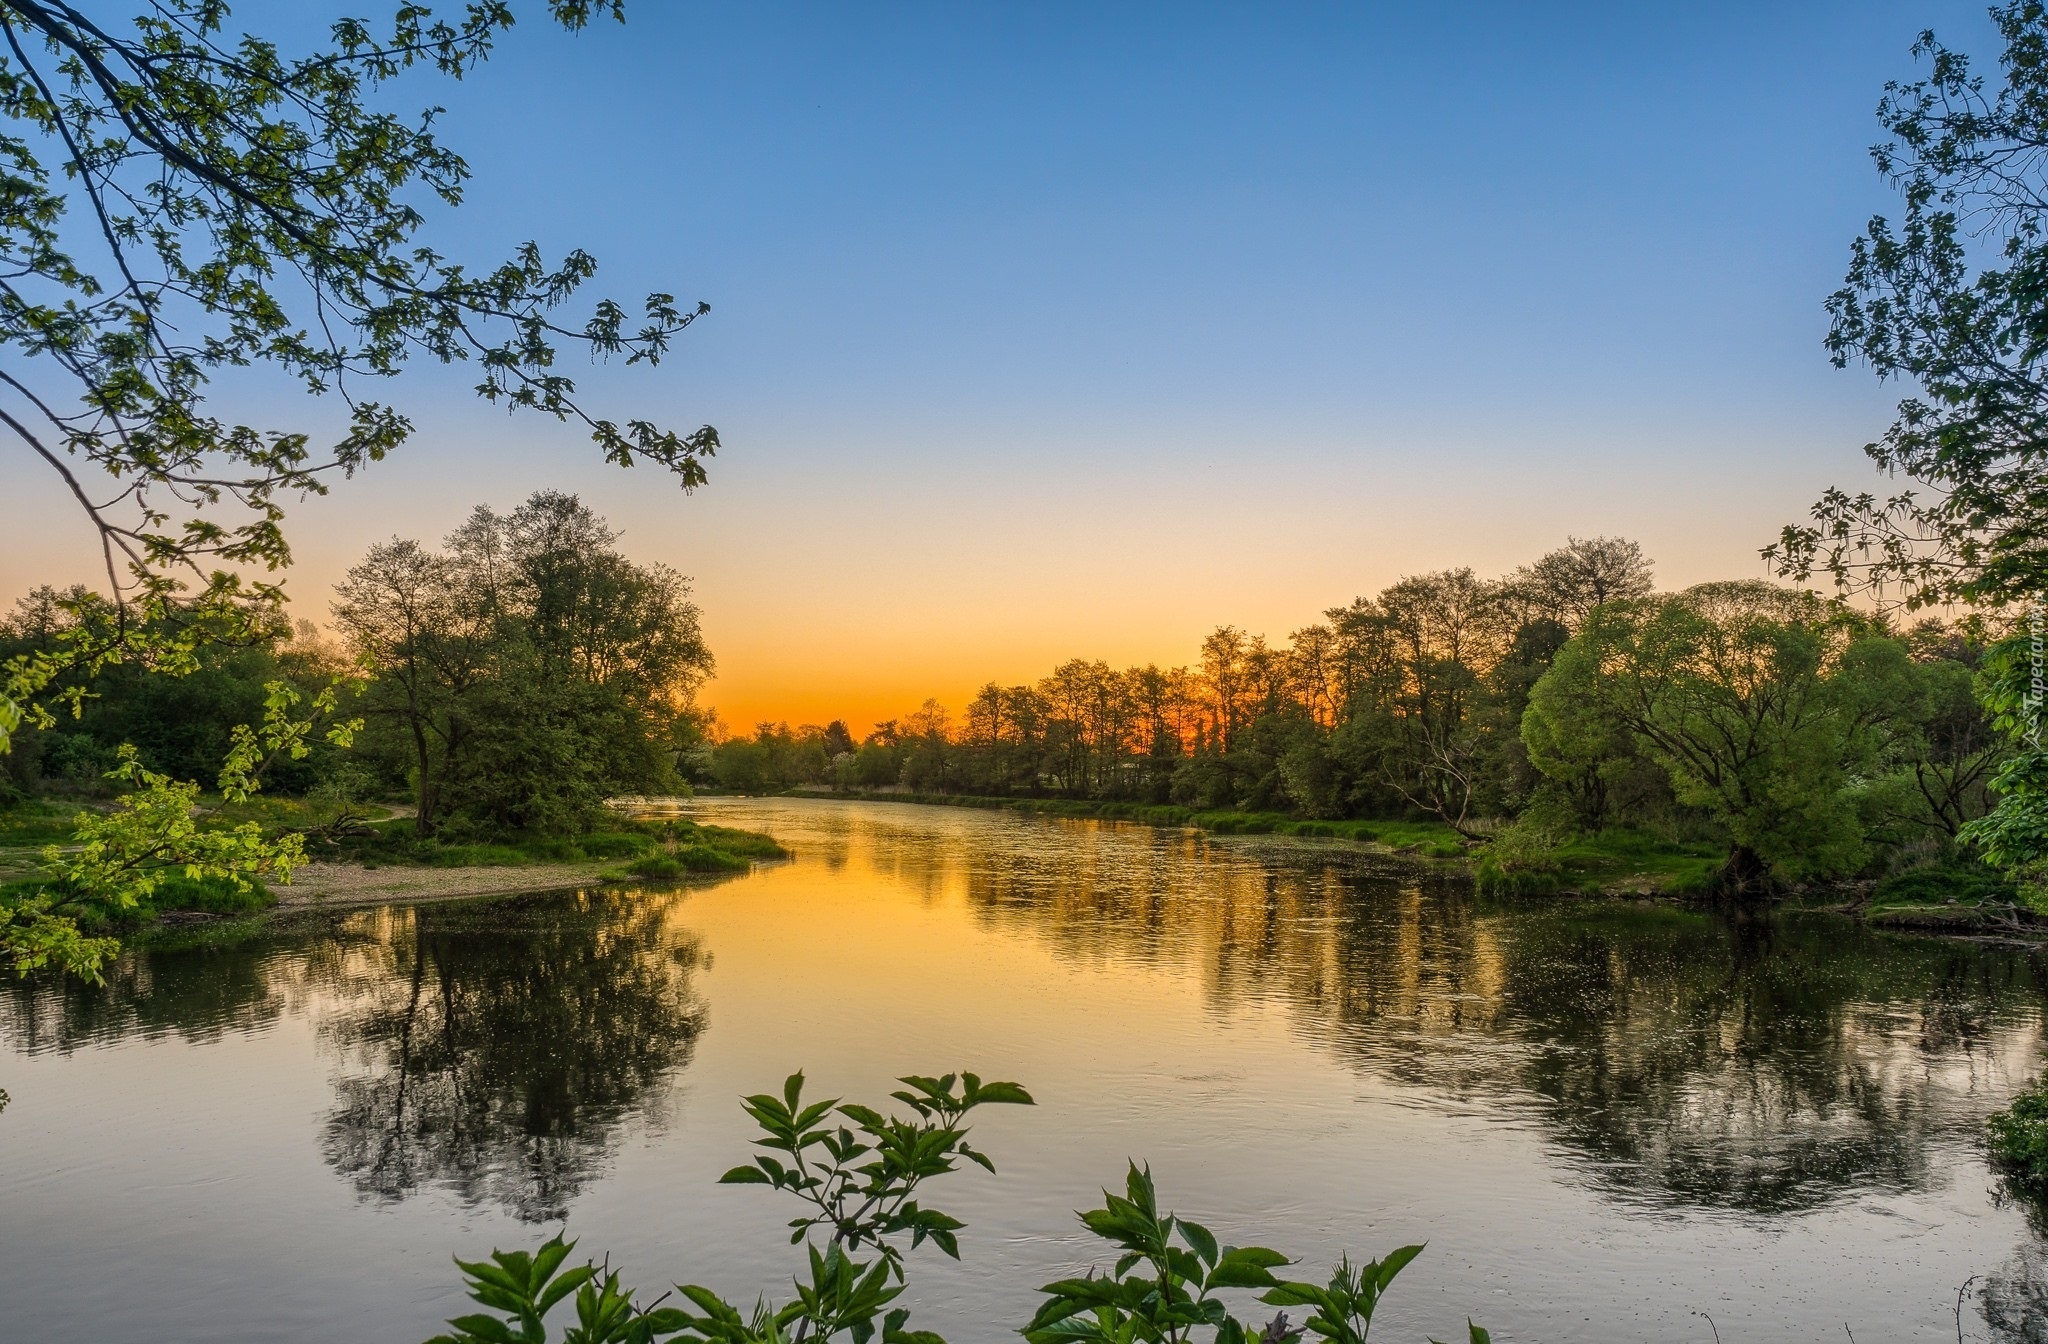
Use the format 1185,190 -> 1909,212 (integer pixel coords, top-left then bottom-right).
0,494 -> 782,969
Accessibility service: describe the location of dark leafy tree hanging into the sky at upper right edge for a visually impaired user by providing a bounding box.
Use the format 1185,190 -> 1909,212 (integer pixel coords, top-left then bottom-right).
1765,0 -> 2048,606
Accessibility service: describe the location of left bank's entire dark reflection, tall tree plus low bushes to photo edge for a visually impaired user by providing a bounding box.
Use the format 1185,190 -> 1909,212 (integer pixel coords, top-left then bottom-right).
4,891 -> 705,1223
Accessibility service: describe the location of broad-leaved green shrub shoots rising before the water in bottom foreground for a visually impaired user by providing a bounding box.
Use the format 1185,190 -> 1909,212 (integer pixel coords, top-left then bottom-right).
430,1074 -> 1491,1344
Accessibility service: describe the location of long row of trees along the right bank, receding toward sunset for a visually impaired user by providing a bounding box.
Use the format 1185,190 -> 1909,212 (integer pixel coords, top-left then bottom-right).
709,537 -> 2005,889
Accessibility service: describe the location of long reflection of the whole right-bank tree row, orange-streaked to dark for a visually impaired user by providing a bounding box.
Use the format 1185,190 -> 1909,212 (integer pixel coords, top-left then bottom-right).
958,836 -> 2042,1213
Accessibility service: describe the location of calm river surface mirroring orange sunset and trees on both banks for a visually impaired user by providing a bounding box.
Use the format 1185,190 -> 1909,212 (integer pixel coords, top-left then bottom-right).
0,801 -> 2048,1344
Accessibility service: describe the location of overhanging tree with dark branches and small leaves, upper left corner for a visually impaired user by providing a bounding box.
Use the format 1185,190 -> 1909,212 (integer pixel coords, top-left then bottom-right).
0,0 -> 717,983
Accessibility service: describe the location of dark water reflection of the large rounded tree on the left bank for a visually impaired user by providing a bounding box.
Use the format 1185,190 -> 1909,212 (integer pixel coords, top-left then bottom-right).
322,891 -> 705,1221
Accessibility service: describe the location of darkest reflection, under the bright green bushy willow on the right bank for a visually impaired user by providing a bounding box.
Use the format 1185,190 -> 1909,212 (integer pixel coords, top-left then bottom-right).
1503,912 -> 2040,1213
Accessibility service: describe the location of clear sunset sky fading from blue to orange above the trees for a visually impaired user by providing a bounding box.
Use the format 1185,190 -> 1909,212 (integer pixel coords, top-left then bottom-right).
0,0 -> 1995,729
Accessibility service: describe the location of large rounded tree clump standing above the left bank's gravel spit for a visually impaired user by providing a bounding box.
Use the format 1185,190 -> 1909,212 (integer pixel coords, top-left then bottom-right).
334,492 -> 713,838
